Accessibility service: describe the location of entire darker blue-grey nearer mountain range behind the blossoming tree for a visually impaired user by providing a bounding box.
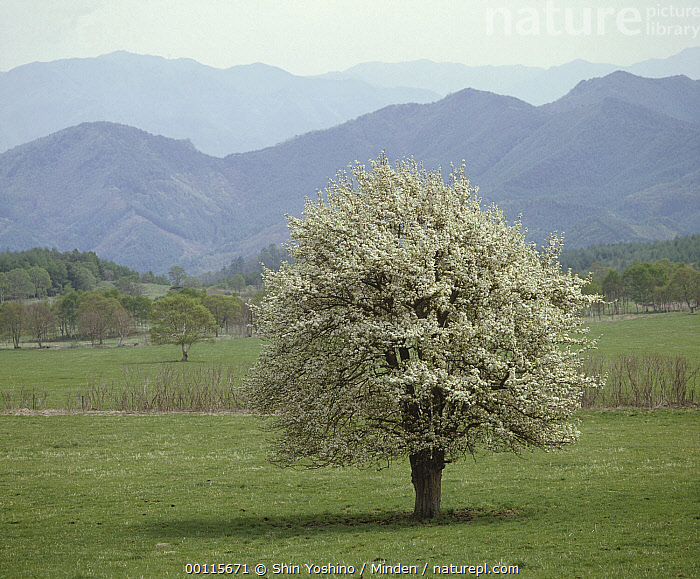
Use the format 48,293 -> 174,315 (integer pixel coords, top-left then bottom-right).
0,72 -> 700,273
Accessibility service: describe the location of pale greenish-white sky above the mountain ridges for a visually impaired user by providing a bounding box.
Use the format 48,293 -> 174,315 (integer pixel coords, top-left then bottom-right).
0,0 -> 700,75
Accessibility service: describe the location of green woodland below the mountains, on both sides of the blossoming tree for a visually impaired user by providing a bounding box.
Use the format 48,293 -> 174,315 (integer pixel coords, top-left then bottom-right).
0,235 -> 700,348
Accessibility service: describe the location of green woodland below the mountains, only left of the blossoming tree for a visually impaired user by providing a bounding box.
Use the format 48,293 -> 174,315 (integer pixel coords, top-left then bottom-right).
0,245 -> 284,348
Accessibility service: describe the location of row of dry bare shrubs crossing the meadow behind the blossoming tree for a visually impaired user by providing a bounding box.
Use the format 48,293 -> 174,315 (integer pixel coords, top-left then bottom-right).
0,354 -> 700,412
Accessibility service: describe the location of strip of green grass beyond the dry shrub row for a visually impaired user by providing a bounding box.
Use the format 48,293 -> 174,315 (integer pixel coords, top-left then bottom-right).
0,314 -> 700,408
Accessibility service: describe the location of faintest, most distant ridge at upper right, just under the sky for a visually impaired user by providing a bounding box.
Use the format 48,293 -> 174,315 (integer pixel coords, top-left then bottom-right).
321,47 -> 700,105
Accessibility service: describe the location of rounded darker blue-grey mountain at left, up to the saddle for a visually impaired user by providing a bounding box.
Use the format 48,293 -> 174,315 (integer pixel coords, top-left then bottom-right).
0,122 -> 241,272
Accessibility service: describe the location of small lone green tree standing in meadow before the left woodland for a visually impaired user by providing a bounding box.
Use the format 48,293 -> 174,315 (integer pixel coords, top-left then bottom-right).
151,294 -> 216,362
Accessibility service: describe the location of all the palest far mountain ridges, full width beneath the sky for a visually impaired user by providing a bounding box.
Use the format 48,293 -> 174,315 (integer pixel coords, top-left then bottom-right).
0,47 -> 700,157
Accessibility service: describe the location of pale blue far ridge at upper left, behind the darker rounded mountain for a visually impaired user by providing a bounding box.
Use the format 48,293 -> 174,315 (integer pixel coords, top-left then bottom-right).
0,52 -> 440,156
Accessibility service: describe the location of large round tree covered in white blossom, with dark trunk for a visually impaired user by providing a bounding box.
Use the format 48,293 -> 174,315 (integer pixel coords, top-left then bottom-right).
249,156 -> 596,519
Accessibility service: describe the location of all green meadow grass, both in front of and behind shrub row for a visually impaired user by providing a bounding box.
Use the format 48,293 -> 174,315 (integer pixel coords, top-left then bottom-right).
0,315 -> 700,578
